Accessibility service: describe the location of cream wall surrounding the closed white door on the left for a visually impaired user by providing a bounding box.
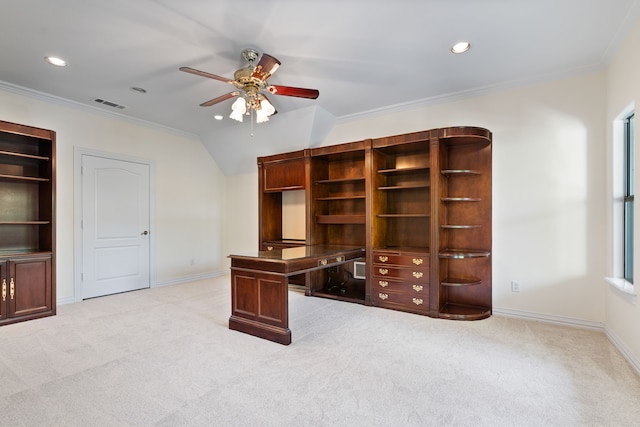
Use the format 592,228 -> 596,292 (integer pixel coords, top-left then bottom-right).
0,90 -> 226,302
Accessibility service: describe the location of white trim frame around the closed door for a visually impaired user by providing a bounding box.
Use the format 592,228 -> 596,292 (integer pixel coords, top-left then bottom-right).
72,146 -> 157,302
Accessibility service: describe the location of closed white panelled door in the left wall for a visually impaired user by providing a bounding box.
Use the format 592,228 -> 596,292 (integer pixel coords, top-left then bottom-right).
81,154 -> 151,299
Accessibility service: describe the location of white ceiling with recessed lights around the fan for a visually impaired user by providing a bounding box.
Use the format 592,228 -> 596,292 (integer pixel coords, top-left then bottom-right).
0,0 -> 640,172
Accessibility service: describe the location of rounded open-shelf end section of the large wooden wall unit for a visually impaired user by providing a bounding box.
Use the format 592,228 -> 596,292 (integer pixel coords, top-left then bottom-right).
432,127 -> 492,320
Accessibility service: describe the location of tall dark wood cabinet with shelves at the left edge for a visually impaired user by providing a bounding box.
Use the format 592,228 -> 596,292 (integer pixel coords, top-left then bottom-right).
0,121 -> 56,325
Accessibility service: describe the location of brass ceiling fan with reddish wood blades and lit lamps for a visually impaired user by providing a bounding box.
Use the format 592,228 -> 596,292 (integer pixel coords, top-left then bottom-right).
180,49 -> 320,123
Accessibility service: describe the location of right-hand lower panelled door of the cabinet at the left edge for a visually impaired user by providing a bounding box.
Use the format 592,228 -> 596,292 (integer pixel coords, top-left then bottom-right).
7,256 -> 52,318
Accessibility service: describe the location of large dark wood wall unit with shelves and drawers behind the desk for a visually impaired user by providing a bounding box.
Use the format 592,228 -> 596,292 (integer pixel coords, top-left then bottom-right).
258,127 -> 492,320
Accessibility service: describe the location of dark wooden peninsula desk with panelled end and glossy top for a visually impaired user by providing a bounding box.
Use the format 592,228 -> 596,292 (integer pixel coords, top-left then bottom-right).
229,245 -> 365,345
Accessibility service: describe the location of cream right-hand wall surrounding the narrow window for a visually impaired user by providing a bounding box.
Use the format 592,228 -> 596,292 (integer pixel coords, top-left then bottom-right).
606,17 -> 640,369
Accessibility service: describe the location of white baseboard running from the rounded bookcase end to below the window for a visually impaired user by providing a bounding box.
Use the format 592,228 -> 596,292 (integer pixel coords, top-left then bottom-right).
493,307 -> 640,374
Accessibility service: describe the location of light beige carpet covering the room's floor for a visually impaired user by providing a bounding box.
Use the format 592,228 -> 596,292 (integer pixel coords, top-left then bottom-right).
0,276 -> 640,426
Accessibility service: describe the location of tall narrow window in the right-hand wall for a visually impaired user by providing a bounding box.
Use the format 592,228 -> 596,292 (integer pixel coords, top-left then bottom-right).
623,114 -> 635,283
